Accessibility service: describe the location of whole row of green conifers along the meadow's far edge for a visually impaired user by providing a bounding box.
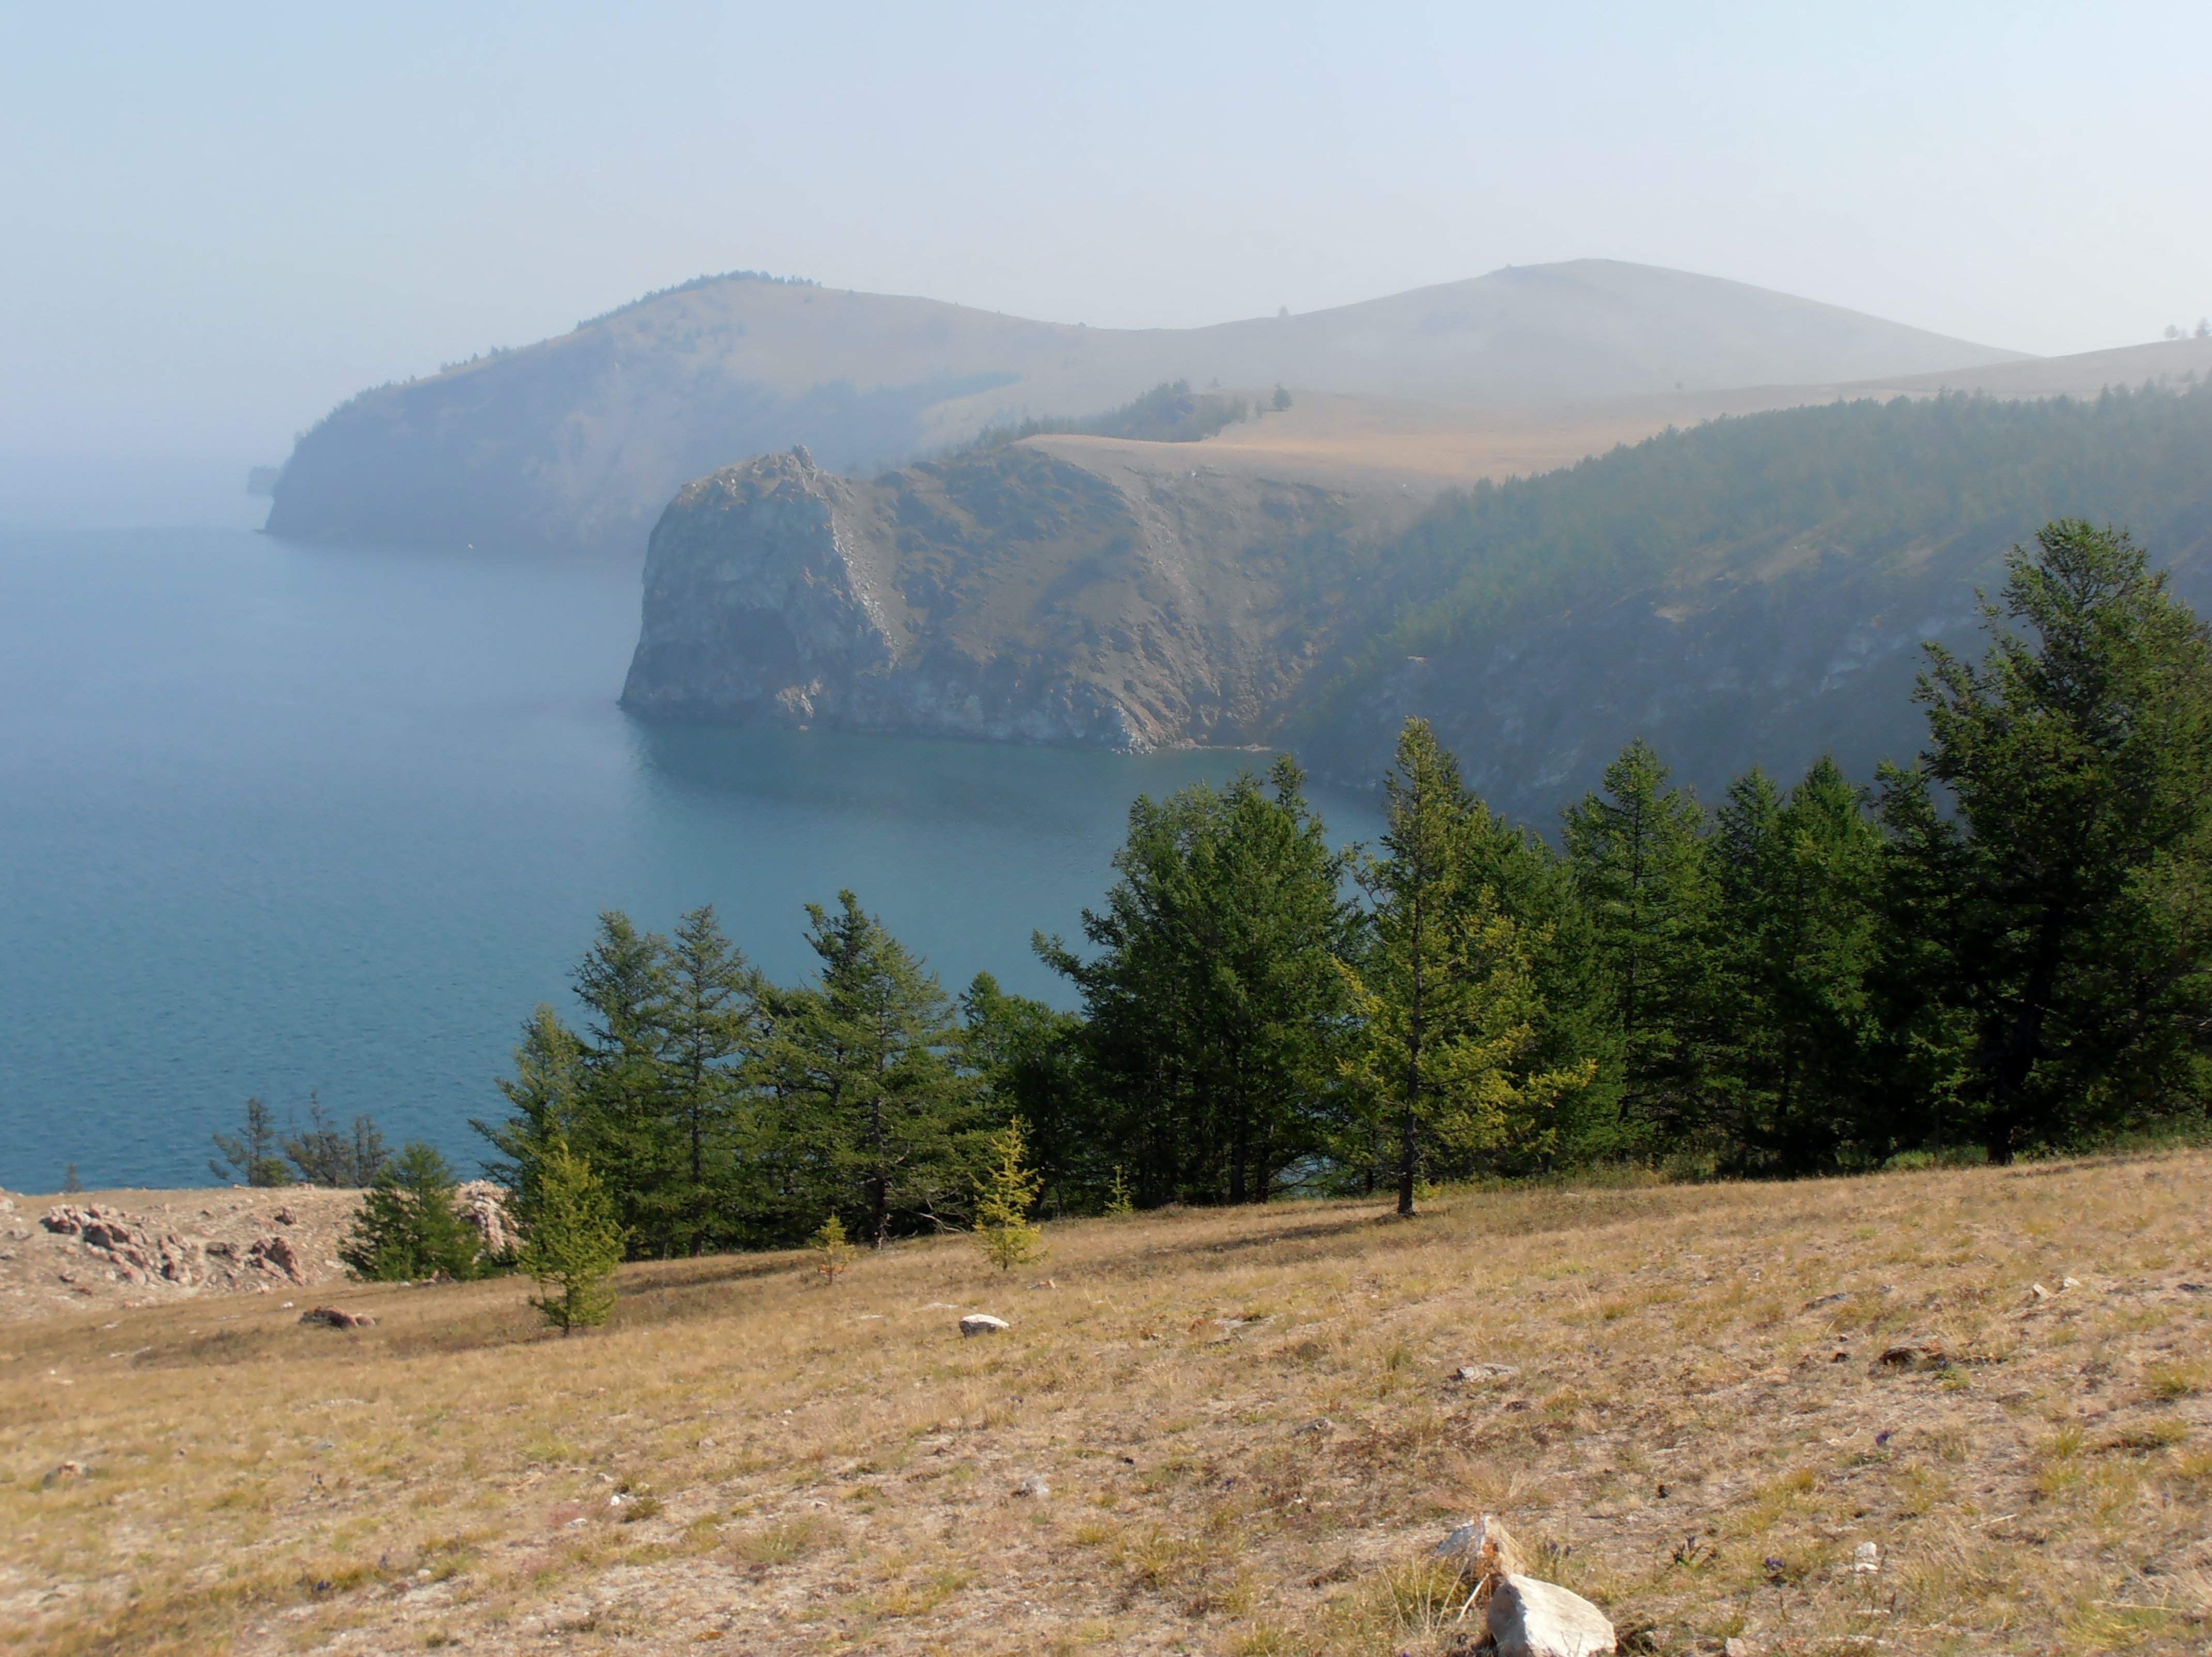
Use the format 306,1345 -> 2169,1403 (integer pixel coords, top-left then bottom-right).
476,522 -> 2212,1257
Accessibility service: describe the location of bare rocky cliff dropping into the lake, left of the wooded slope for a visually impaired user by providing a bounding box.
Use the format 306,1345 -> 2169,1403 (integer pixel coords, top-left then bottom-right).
621,443 -> 1382,750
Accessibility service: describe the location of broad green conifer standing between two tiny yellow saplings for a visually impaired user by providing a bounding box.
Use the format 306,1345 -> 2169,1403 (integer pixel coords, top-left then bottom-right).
774,892 -> 975,1248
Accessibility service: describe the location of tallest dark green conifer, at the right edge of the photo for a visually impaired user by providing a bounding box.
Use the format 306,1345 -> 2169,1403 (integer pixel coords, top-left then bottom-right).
1884,522 -> 2212,1162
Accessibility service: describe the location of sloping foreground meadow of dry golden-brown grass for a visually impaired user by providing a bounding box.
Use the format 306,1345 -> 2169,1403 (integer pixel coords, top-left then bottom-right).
0,1155 -> 2212,1655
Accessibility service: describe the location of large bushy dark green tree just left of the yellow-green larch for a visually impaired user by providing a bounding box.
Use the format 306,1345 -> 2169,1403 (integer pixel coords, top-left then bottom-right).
1035,759 -> 1356,1203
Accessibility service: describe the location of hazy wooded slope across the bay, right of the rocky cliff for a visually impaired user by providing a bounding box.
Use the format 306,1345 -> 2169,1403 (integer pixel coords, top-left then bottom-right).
1285,385 -> 2212,827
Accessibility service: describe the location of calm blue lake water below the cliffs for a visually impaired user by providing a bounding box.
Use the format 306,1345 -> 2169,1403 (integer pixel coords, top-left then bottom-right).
0,531 -> 1376,1190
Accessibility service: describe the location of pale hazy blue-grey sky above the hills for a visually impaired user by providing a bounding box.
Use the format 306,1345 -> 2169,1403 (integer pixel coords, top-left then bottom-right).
0,0 -> 2212,522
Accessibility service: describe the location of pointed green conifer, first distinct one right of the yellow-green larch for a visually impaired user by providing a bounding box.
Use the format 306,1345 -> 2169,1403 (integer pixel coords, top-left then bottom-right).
1566,737 -> 1708,1133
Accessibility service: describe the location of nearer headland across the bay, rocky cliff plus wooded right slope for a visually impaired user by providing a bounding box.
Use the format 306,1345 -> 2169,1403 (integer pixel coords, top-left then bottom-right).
624,385 -> 2212,823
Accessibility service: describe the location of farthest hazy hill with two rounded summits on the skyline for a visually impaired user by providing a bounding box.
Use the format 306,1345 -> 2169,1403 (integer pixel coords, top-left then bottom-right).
268,259 -> 2019,557
